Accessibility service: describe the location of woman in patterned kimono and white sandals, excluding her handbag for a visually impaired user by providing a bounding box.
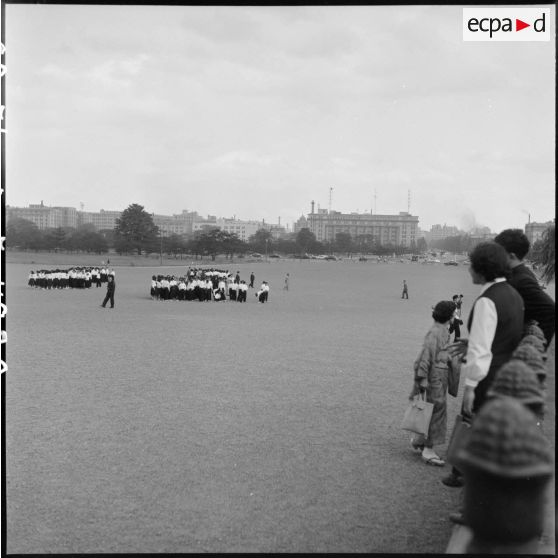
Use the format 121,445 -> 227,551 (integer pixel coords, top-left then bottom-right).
409,300 -> 459,467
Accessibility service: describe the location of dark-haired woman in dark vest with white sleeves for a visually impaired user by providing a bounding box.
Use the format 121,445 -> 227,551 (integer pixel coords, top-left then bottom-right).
442,242 -> 524,494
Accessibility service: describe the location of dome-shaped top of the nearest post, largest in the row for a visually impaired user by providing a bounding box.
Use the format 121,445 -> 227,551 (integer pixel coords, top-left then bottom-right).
456,397 -> 554,479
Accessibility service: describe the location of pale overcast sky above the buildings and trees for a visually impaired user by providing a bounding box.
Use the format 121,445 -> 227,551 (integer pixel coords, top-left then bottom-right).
5,4 -> 555,232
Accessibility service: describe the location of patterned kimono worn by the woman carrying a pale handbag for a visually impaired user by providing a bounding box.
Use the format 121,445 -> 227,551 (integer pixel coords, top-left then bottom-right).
411,322 -> 453,447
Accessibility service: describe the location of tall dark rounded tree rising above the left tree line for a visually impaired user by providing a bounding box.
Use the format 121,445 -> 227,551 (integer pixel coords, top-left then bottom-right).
114,203 -> 158,255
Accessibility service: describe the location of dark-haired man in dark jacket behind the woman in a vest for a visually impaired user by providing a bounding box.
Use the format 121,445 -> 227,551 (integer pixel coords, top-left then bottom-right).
494,229 -> 556,347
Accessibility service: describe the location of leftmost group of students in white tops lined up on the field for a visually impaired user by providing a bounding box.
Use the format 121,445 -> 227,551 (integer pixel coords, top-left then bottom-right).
27,267 -> 115,290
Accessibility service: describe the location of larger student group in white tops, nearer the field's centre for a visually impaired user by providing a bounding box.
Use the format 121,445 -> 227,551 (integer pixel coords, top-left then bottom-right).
150,268 -> 269,302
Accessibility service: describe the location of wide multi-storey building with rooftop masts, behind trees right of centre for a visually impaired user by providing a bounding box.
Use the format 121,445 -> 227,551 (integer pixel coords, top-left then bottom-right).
307,202 -> 419,247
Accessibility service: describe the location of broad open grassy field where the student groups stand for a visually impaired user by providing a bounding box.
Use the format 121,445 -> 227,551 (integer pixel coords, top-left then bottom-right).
6,258 -> 555,553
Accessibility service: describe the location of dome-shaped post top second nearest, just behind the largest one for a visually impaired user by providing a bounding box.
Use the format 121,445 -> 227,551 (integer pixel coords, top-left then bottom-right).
486,360 -> 544,405
